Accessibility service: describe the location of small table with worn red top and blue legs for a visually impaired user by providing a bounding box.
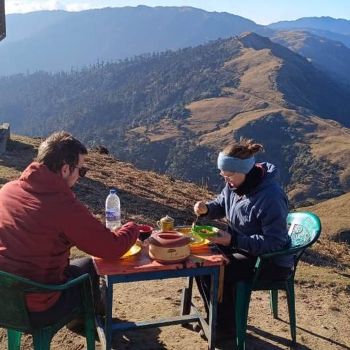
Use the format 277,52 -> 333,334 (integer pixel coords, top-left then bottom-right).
93,246 -> 226,350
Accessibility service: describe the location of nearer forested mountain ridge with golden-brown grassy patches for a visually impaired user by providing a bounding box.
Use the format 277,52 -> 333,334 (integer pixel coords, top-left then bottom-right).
0,33 -> 350,204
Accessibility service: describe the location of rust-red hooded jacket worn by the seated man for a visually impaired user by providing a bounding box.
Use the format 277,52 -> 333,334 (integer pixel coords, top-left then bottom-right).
0,162 -> 139,311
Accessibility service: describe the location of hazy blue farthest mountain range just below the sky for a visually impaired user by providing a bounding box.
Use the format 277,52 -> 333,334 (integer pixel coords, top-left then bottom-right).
0,6 -> 350,75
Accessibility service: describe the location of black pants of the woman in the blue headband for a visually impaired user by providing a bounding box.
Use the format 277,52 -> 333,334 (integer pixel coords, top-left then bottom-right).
196,252 -> 291,329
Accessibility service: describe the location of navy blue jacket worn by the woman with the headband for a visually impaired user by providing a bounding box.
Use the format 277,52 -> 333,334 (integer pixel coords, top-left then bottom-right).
207,163 -> 293,267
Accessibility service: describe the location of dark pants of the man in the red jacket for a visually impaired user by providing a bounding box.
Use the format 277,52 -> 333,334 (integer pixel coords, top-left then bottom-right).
29,258 -> 100,326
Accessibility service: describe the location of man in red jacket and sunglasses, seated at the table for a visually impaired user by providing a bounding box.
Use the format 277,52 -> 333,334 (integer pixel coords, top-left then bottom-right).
0,132 -> 139,325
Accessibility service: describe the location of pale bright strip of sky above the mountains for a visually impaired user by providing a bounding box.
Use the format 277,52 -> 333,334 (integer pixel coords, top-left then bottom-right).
5,0 -> 350,24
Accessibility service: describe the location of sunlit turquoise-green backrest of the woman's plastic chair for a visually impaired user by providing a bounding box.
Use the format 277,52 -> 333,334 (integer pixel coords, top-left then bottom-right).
287,212 -> 321,262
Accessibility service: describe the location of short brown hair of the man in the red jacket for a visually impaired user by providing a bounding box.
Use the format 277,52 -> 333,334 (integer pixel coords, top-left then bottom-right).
36,131 -> 88,173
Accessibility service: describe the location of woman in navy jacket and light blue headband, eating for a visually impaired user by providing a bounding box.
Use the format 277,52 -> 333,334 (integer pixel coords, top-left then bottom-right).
194,139 -> 293,338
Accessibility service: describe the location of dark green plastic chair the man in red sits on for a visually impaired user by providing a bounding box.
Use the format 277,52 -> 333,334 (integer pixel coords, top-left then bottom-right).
0,271 -> 95,350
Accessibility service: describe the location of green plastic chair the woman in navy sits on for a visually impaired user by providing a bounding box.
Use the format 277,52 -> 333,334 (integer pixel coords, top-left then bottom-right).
235,212 -> 321,350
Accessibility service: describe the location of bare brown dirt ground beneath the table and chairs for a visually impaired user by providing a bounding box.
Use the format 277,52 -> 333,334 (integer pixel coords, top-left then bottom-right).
0,278 -> 350,350
